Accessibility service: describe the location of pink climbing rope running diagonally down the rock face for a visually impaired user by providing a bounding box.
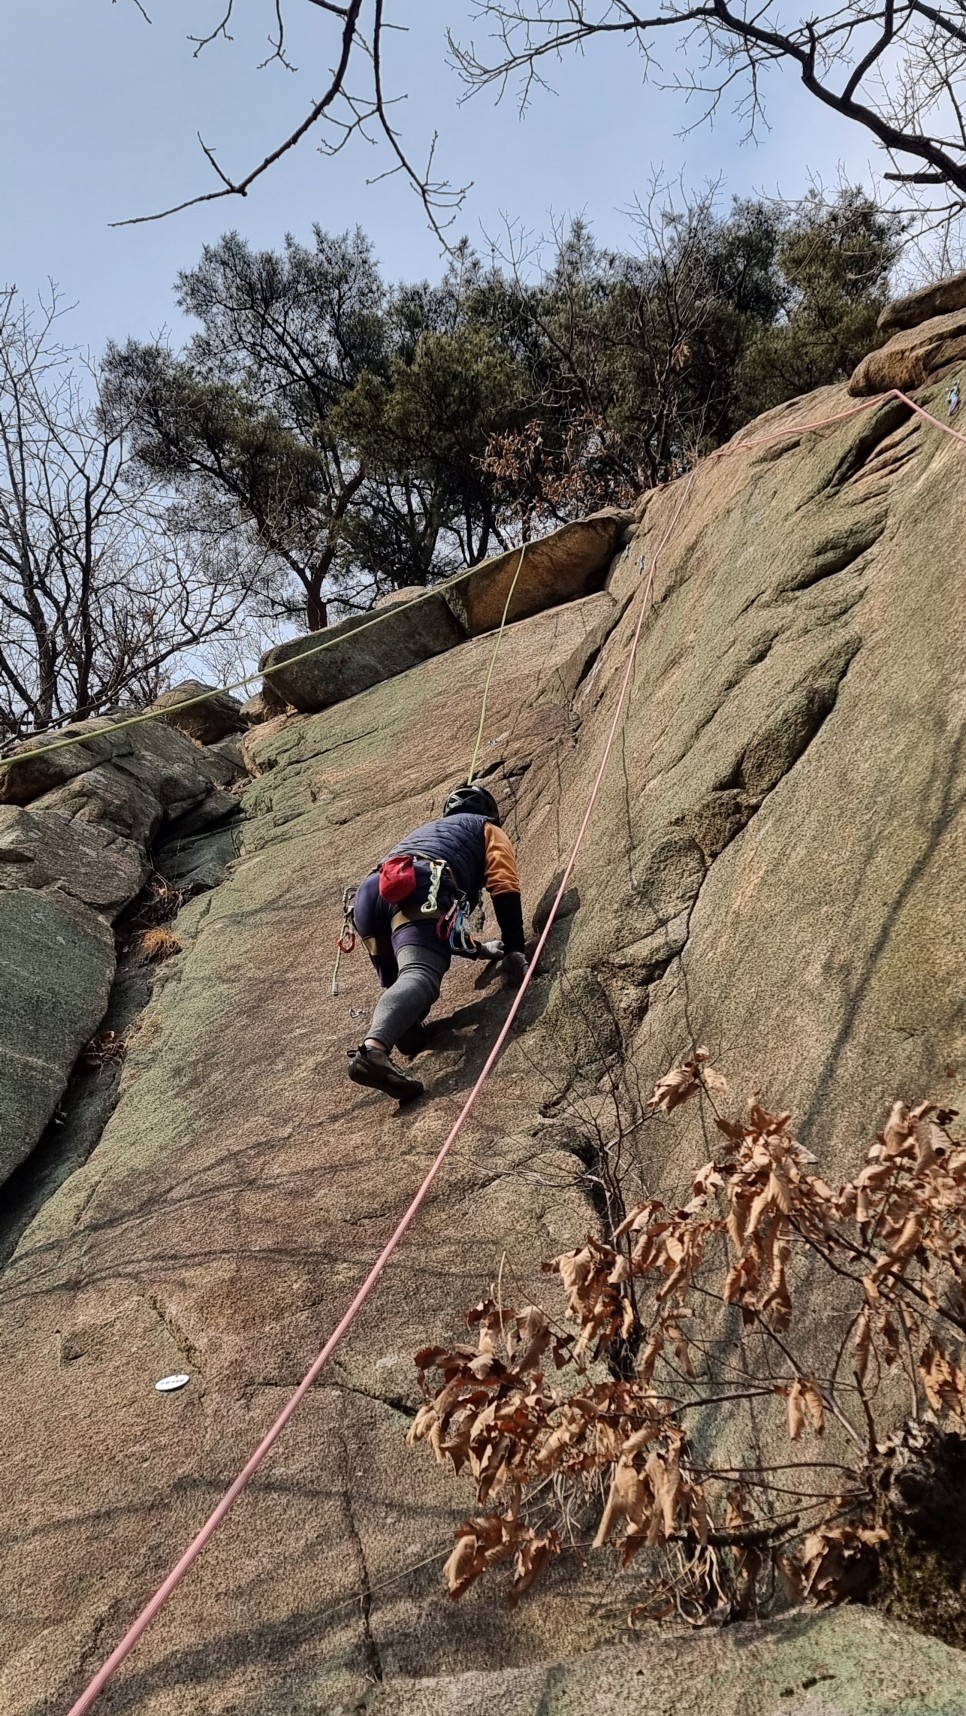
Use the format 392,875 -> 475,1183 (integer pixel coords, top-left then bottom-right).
69,388 -> 966,1716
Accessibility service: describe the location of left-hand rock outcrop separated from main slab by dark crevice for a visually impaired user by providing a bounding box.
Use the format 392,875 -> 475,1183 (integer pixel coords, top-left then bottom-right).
0,721 -> 238,1184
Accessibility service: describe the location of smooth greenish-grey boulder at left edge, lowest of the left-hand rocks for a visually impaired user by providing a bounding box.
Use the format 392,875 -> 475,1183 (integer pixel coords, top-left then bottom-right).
0,887 -> 115,1181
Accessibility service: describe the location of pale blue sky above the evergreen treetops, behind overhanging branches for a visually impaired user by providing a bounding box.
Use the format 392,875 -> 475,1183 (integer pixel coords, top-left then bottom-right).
0,0 -> 872,353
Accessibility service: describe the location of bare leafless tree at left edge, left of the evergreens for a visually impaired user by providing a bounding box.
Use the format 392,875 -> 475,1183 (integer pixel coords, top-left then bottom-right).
0,288 -> 251,741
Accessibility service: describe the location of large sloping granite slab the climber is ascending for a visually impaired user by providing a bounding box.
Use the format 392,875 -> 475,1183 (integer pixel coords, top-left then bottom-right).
0,368 -> 966,1716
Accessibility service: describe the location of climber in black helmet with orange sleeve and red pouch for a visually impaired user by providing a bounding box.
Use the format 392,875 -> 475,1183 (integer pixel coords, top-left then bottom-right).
348,784 -> 527,1102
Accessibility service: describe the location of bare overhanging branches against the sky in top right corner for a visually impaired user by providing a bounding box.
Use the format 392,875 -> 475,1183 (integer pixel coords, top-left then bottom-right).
450,0 -> 966,233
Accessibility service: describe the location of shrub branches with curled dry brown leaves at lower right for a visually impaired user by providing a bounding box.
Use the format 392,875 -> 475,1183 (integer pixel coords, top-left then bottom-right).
408,1050 -> 966,1622
